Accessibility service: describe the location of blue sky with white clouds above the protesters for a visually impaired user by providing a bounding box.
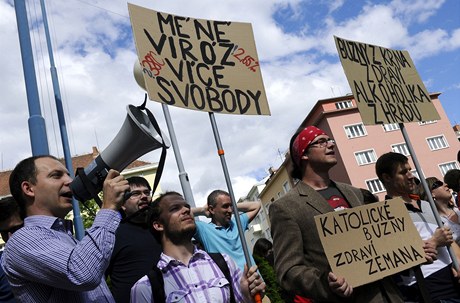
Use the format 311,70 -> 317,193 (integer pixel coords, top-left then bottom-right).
0,0 -> 460,206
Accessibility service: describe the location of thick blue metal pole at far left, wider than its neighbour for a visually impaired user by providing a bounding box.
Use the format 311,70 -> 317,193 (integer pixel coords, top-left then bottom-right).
14,0 -> 49,156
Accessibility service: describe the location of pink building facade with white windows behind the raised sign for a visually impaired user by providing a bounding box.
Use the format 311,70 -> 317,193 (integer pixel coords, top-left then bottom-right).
302,93 -> 460,199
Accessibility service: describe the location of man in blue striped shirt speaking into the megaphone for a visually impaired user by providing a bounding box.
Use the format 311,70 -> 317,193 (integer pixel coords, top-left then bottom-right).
2,156 -> 129,303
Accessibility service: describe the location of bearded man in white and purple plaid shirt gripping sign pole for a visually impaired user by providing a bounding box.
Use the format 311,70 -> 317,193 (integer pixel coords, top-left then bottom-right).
131,192 -> 265,303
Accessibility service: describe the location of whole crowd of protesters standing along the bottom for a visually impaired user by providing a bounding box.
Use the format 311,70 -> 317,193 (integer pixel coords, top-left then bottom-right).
0,126 -> 460,303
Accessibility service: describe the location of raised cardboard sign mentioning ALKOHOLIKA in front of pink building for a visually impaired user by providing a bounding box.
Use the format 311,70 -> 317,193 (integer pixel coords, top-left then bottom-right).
334,37 -> 440,125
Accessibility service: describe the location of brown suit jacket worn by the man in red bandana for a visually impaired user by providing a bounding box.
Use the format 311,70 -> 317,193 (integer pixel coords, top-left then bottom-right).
270,182 -> 403,303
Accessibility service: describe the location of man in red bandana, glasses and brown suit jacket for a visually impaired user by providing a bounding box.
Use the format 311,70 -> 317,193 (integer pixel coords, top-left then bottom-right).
270,126 -> 403,302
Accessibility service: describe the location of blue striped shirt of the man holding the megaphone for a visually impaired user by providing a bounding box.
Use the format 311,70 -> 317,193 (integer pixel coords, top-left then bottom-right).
2,209 -> 120,303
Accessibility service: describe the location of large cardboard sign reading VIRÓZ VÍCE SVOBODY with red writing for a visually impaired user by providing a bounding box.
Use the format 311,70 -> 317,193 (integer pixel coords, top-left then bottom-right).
128,4 -> 270,115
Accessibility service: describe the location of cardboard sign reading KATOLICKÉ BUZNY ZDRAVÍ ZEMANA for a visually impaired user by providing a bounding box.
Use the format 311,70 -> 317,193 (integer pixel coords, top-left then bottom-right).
315,198 -> 426,287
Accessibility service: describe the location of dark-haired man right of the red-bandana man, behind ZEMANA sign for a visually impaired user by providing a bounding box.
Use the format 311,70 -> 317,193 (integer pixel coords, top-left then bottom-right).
375,152 -> 460,303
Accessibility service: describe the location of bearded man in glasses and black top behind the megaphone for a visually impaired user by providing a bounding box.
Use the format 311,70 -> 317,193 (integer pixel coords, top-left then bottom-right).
106,176 -> 161,303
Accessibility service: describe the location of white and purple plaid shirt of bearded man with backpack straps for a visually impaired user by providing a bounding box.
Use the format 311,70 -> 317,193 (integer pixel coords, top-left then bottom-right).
131,248 -> 244,303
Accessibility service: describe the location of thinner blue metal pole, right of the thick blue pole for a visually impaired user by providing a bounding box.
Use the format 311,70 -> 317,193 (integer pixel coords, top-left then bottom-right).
40,0 -> 85,240
